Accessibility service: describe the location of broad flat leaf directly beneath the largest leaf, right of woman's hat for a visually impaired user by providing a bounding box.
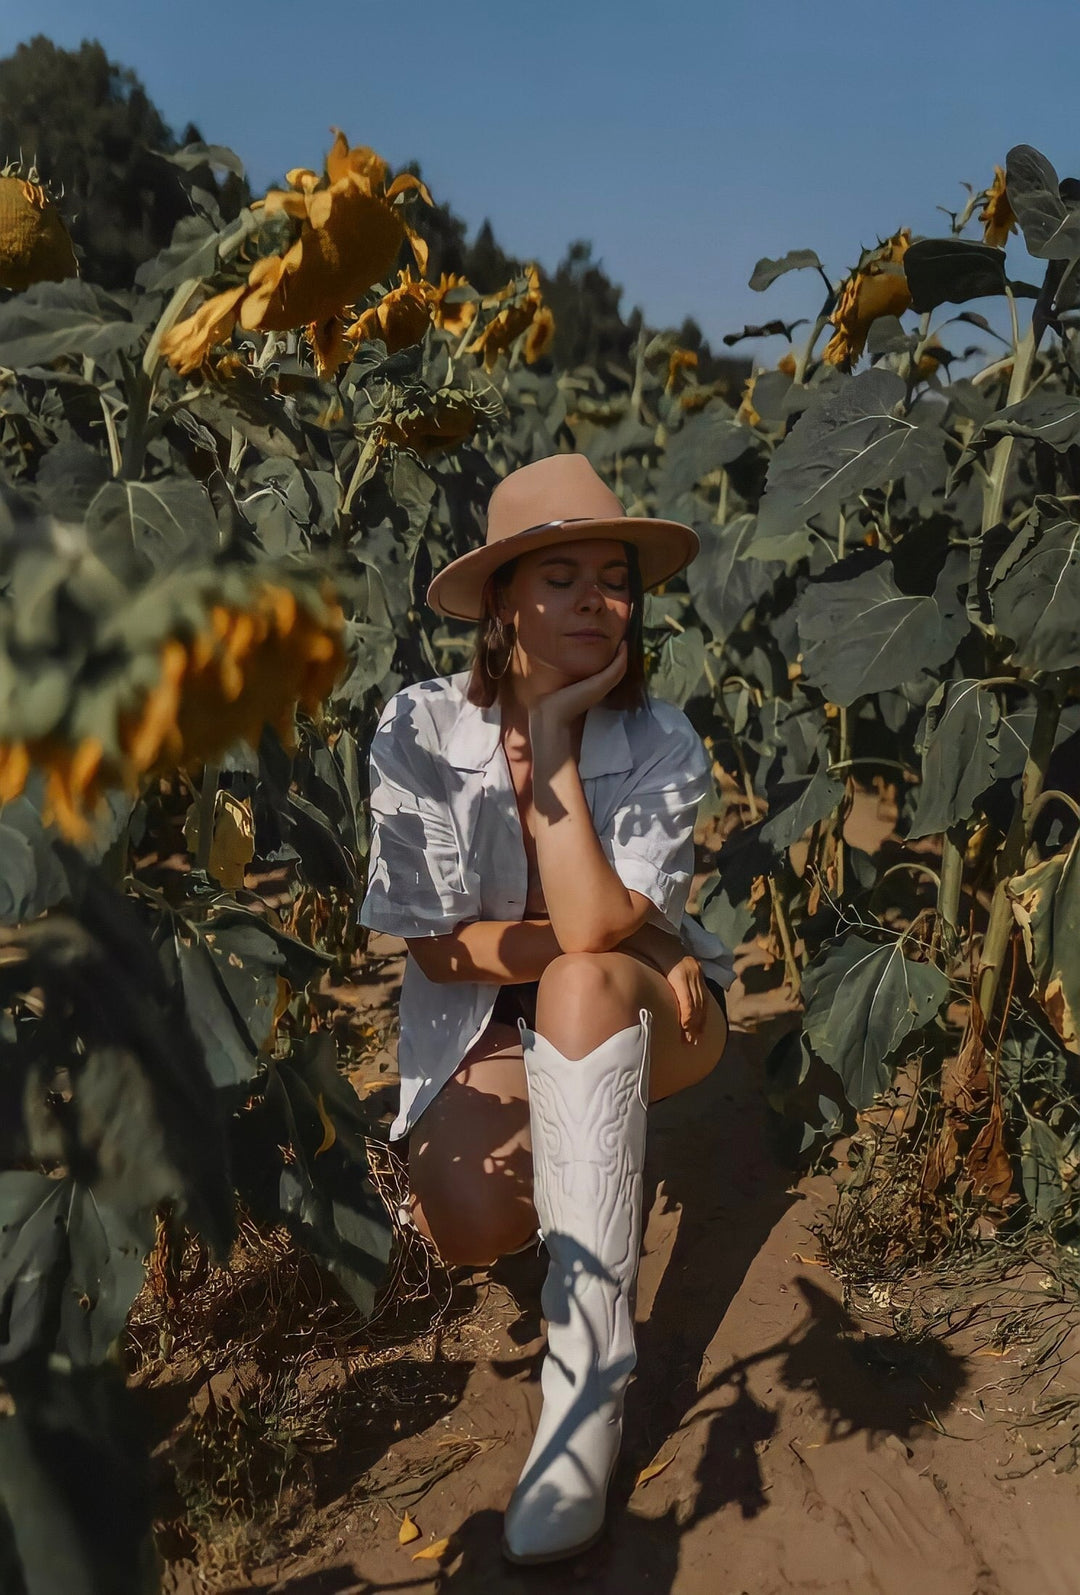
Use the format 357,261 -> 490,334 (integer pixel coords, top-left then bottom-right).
796,560 -> 967,705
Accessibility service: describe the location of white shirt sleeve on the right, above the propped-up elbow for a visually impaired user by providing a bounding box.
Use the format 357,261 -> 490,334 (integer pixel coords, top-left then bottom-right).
600,716 -> 710,927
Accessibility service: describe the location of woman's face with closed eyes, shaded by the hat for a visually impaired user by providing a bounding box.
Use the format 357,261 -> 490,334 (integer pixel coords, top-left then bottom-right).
499,538 -> 630,681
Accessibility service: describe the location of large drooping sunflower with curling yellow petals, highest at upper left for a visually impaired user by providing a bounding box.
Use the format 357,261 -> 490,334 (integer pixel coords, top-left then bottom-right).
161,129 -> 434,375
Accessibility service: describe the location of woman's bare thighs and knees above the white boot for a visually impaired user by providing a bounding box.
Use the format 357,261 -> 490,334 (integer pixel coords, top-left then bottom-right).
408,952 -> 727,1265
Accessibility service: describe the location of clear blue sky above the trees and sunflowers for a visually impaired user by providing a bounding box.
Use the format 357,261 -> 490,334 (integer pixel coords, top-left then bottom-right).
0,0 -> 1080,364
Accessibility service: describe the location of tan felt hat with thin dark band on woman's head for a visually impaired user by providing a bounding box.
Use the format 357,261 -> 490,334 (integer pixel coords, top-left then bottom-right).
428,455 -> 700,620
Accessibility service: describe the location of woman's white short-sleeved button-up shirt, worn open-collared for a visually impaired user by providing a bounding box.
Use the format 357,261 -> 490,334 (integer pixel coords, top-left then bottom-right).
361,671 -> 734,1140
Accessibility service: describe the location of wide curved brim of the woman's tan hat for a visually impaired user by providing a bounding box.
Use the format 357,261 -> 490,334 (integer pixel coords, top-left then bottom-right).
428,515 -> 700,620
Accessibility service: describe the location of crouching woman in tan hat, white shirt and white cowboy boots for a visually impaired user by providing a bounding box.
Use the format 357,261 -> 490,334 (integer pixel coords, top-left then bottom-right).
361,455 -> 732,1563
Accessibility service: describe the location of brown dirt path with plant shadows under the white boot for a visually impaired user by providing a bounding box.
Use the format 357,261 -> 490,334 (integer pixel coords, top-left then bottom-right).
191,969 -> 1080,1595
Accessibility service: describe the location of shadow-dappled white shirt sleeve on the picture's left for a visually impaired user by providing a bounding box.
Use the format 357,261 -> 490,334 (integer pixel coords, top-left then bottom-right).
361,694 -> 480,938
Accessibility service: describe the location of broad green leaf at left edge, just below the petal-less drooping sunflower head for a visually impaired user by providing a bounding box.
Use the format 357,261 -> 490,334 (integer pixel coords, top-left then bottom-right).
0,278 -> 144,370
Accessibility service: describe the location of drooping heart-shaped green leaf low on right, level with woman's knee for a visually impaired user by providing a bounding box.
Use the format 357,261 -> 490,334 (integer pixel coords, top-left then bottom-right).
802,936 -> 949,1109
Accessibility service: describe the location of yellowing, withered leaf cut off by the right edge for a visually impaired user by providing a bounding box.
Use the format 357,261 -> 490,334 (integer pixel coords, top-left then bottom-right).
1008,842 -> 1080,1053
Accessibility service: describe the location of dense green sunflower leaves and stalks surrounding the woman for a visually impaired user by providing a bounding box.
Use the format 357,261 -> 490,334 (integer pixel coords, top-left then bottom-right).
0,109 -> 1080,1595
